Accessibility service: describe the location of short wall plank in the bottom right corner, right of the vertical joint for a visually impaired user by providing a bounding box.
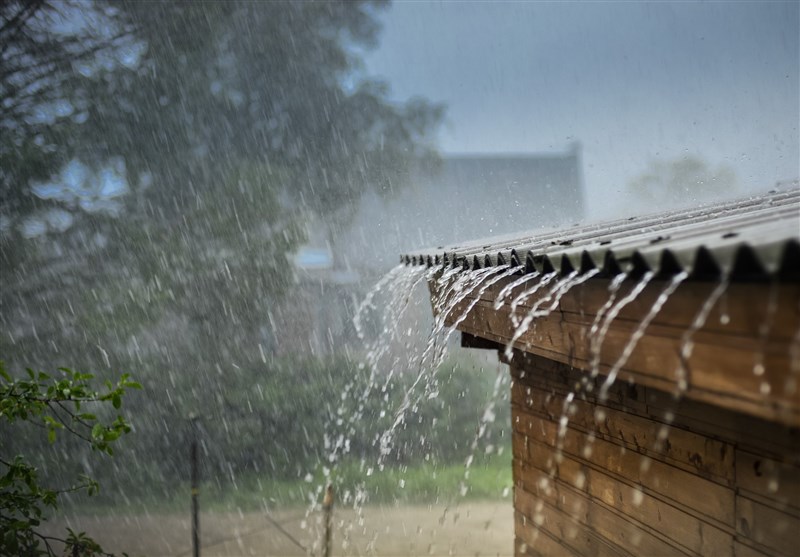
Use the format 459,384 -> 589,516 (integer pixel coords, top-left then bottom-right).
736,496 -> 800,555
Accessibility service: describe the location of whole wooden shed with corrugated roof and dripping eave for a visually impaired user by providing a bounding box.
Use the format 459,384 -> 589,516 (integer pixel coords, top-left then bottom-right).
402,188 -> 800,556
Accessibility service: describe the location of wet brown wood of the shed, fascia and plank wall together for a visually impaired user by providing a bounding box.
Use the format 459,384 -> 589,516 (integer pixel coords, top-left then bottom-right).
431,268 -> 800,557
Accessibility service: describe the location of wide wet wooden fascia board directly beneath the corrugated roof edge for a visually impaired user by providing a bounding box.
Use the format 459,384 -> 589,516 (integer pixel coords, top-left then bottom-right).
434,272 -> 800,426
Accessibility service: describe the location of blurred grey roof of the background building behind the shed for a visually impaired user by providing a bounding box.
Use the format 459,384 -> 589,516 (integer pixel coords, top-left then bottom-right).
336,142 -> 585,270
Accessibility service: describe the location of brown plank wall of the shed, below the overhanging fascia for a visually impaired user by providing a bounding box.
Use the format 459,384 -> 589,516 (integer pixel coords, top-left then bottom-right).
511,351 -> 800,556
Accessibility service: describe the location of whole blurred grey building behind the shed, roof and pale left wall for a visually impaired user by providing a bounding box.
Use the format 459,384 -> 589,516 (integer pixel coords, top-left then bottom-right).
282,142 -> 585,354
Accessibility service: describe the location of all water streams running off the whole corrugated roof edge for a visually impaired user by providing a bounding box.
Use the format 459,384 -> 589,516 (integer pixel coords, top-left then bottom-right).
330,265 -> 784,552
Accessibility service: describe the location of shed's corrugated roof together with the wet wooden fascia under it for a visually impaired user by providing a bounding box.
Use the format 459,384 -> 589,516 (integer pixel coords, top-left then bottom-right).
401,188 -> 800,426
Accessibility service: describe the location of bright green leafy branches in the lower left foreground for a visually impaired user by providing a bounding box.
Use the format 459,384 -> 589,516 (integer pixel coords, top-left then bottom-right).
0,362 -> 141,555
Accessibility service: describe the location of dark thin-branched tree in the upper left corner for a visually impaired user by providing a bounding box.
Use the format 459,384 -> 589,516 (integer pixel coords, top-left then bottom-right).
0,0 -> 133,247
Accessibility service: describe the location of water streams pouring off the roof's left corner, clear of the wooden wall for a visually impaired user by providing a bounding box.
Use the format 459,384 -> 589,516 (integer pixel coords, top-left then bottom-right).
306,266 -> 524,544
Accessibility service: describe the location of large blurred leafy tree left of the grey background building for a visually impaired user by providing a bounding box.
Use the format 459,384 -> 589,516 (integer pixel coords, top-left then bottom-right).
0,0 -> 442,500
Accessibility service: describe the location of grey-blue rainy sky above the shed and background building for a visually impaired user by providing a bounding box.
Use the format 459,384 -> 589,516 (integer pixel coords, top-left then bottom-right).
365,2 -> 800,216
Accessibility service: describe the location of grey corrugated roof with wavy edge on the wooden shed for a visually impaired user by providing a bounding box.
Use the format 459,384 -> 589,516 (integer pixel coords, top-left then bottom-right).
401,187 -> 800,280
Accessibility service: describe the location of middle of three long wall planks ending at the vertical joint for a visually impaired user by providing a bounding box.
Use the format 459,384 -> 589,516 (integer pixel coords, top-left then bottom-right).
512,405 -> 734,526
